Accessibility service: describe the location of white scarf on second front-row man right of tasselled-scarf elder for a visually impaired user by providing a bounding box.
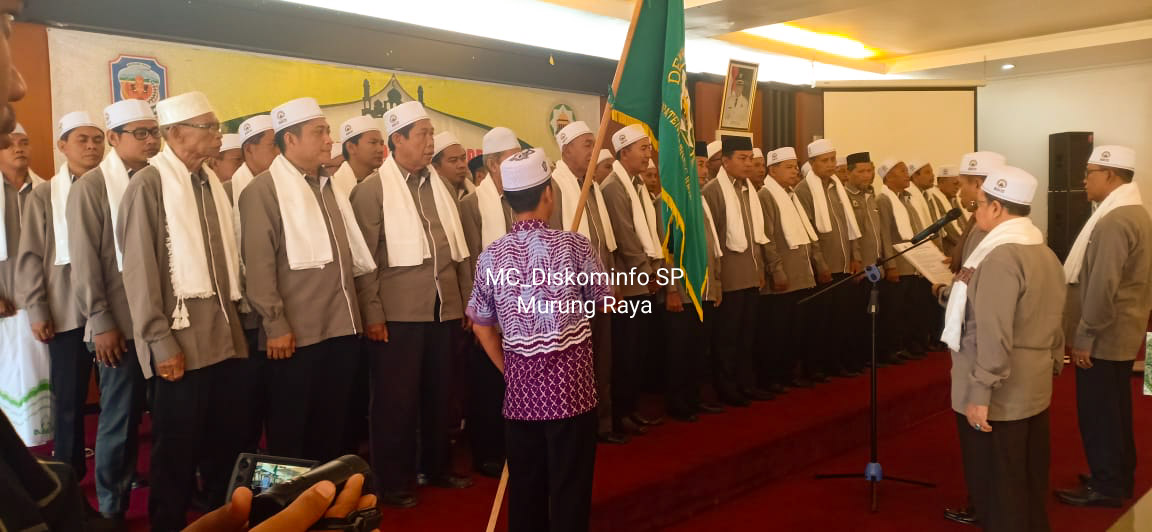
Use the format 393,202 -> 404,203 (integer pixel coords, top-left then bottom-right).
379,157 -> 467,267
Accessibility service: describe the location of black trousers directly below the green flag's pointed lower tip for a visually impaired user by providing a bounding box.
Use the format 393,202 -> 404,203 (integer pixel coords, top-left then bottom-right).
664,304 -> 705,416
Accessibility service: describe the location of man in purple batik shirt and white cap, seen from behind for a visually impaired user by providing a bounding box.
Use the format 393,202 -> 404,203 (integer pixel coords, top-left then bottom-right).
468,149 -> 612,531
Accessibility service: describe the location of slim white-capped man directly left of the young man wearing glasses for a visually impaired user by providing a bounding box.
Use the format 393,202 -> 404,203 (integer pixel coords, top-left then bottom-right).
16,111 -> 104,478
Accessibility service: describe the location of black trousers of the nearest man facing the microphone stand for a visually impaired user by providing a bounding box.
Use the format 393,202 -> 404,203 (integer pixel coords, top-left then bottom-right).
956,410 -> 1051,532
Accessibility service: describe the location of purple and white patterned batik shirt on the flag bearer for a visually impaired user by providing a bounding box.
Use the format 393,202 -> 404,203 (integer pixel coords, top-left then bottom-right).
468,220 -> 612,420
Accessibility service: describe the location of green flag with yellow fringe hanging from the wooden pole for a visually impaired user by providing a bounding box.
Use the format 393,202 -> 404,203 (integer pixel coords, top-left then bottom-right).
612,0 -> 708,319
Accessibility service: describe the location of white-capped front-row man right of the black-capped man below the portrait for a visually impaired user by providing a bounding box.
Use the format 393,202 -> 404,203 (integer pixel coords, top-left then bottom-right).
755,146 -> 833,393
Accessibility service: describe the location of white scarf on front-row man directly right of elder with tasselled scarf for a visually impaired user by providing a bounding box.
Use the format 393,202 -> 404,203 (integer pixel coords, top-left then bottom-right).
268,154 -> 376,276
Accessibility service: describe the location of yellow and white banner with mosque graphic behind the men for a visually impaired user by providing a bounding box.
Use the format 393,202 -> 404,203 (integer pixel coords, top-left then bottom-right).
47,28 -> 600,165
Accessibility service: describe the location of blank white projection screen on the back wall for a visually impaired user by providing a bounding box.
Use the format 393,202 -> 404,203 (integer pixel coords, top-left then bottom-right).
824,88 -> 976,180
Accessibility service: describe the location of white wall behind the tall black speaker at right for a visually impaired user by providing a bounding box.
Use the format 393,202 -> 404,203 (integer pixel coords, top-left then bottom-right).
977,62 -> 1152,231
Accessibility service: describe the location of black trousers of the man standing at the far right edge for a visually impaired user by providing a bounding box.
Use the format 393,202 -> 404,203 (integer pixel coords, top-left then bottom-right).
1076,358 -> 1136,499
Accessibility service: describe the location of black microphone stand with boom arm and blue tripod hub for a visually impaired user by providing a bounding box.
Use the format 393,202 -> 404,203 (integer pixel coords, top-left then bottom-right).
799,229 -> 939,512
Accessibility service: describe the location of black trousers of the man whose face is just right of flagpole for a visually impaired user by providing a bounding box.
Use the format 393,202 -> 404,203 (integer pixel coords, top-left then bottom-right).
612,296 -> 652,431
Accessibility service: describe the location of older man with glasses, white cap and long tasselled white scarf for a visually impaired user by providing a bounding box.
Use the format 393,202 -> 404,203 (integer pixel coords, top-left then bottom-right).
115,92 -> 249,531
